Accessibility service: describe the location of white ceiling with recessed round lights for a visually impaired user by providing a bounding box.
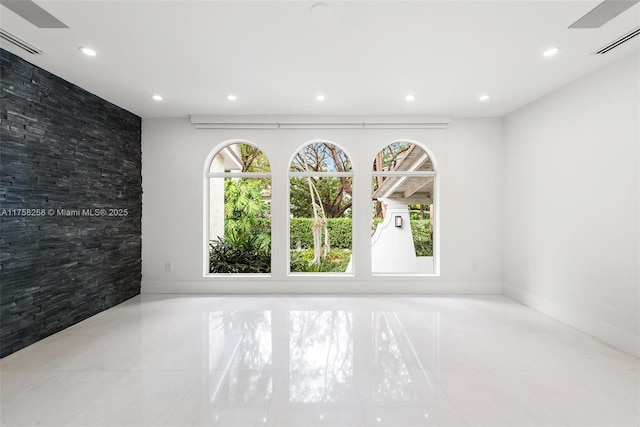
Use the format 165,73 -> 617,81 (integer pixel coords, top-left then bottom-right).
0,0 -> 640,118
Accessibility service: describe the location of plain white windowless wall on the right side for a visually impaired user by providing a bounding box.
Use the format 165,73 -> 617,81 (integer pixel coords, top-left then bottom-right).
504,54 -> 640,355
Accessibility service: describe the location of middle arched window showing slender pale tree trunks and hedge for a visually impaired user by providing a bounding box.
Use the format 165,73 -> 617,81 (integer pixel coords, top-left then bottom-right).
289,141 -> 353,273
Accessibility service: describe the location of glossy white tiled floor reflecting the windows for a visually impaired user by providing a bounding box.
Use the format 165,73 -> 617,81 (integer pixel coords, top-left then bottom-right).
0,295 -> 640,427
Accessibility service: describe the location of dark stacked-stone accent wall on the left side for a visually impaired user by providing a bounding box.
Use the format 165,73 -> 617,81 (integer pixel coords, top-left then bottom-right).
0,49 -> 142,357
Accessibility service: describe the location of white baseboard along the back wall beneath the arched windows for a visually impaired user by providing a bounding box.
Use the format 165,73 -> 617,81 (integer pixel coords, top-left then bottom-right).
142,278 -> 502,295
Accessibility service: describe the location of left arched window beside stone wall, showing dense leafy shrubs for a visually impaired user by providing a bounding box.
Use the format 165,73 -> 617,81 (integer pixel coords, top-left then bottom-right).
206,141 -> 271,273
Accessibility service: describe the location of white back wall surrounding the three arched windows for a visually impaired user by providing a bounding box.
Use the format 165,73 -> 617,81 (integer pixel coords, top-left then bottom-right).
142,118 -> 503,293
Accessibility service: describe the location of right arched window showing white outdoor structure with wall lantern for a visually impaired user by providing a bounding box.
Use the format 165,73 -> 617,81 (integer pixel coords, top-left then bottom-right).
371,141 -> 437,274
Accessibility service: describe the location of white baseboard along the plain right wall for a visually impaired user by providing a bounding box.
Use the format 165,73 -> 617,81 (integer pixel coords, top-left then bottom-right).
503,283 -> 640,357
